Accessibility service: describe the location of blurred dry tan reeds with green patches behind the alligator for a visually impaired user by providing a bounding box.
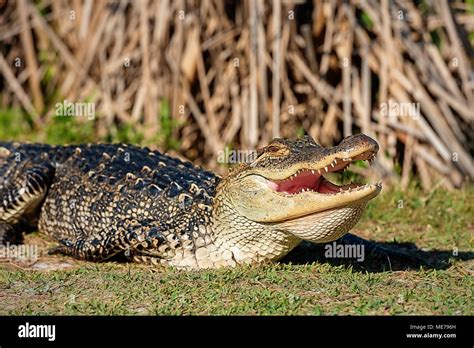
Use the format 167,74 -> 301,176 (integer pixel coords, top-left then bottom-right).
0,0 -> 474,189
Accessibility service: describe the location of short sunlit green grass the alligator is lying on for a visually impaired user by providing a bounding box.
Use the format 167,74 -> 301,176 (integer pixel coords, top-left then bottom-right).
0,186 -> 474,315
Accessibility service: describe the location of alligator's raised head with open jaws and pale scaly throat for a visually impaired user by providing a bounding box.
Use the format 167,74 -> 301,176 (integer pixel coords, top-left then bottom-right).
214,134 -> 381,261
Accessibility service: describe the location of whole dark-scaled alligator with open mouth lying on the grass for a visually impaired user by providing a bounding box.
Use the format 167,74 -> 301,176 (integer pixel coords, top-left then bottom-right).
0,134 -> 381,269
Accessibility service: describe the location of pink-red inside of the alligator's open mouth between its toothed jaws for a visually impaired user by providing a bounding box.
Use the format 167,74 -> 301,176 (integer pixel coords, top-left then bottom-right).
267,151 -> 378,195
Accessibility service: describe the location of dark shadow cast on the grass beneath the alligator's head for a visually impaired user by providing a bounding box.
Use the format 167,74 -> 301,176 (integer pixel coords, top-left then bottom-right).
280,234 -> 474,273
